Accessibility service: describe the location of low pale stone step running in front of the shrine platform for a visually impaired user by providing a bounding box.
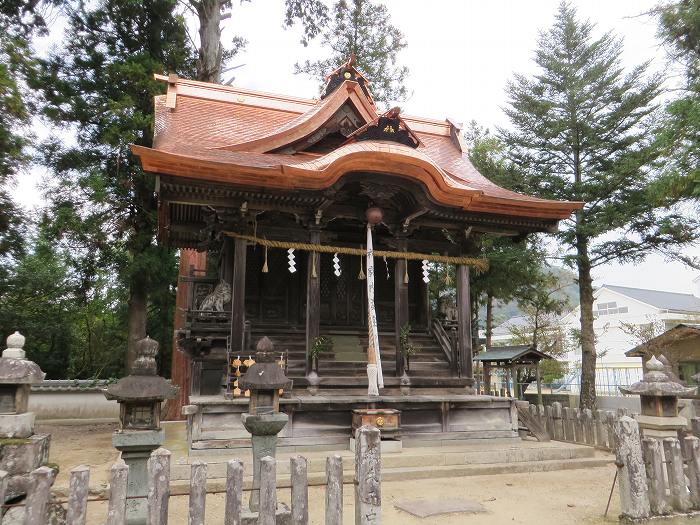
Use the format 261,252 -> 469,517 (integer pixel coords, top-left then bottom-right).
171,439 -> 596,480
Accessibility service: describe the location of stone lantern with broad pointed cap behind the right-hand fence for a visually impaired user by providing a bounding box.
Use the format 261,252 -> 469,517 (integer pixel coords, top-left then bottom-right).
620,356 -> 695,439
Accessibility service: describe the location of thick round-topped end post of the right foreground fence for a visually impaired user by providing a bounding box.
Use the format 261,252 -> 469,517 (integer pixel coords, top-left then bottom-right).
614,416 -> 650,520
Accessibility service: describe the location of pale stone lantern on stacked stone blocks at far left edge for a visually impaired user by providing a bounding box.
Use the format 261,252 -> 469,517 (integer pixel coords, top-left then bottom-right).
0,332 -> 53,504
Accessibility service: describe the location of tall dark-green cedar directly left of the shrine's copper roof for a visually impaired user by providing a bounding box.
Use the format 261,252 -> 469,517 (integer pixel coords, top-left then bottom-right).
34,0 -> 195,366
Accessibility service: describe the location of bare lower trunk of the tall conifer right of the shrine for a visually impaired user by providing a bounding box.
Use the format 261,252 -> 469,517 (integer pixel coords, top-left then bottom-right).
576,234 -> 596,409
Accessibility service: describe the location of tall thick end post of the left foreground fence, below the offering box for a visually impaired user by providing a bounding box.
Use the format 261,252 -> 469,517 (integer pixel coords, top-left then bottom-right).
355,425 -> 382,525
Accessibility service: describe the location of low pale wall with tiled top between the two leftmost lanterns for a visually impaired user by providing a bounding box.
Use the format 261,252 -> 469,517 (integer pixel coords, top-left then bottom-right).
29,380 -> 119,421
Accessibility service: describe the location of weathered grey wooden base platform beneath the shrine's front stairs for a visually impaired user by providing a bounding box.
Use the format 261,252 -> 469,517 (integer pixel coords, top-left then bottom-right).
185,389 -> 518,454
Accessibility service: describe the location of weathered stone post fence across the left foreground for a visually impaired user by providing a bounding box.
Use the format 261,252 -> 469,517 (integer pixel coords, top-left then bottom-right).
0,426 -> 381,525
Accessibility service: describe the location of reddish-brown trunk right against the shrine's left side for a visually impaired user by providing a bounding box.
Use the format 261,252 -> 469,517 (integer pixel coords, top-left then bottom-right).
163,250 -> 207,421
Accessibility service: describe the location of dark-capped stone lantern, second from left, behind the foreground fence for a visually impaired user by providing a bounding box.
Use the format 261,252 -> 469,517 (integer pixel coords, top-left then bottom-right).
104,337 -> 178,525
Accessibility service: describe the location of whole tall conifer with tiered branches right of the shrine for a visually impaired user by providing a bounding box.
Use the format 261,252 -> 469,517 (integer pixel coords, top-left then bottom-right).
500,3 -> 697,408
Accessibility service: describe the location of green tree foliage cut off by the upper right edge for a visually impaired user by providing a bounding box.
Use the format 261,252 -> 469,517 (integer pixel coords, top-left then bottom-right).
658,0 -> 700,199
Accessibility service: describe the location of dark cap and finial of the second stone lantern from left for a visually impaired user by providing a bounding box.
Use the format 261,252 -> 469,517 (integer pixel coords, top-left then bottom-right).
104,337 -> 178,402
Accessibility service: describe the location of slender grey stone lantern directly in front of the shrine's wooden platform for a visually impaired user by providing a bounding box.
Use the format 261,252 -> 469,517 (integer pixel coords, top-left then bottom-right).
238,337 -> 292,523
